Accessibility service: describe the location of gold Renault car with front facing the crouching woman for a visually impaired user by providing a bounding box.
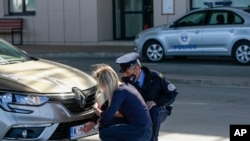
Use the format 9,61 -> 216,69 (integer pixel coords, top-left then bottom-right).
0,39 -> 100,140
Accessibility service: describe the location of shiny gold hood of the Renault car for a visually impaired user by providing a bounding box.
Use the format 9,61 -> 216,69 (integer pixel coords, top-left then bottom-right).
0,59 -> 97,93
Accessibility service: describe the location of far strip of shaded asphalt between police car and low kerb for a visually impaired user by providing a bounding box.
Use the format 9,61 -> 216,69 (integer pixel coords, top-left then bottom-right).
41,56 -> 250,87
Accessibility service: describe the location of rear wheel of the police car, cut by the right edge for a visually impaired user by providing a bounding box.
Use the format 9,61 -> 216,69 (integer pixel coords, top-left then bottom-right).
234,41 -> 250,65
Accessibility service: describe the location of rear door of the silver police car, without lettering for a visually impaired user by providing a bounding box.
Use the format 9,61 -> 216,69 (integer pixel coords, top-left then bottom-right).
200,10 -> 239,55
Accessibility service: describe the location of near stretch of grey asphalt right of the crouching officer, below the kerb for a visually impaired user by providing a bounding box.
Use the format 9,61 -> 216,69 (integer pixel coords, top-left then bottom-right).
78,85 -> 250,141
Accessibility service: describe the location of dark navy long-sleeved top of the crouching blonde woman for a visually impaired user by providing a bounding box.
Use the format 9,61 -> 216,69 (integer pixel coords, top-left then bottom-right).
100,84 -> 152,128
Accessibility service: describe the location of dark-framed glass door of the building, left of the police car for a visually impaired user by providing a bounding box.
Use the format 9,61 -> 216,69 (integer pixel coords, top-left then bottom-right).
113,0 -> 153,40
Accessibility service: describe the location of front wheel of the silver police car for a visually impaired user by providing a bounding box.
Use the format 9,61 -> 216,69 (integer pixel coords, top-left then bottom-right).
143,41 -> 165,62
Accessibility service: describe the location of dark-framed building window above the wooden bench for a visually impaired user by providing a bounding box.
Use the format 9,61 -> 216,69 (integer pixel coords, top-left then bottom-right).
8,0 -> 36,15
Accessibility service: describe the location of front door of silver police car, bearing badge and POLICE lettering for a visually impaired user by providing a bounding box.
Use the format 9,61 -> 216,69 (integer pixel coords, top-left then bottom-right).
165,10 -> 207,55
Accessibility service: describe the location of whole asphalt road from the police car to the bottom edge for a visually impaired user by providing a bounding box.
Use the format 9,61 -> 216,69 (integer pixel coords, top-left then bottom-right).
38,56 -> 250,141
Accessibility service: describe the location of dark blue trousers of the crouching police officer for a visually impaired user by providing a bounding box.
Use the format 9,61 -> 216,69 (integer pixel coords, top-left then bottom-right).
149,106 -> 170,141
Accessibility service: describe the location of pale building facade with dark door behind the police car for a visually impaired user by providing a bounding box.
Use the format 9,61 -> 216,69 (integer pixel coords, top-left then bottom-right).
0,0 -> 250,45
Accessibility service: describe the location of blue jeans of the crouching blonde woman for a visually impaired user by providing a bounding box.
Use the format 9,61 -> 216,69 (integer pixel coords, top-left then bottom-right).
99,124 -> 152,141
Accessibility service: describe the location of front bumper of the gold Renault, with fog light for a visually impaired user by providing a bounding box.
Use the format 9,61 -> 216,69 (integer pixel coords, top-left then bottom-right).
0,102 -> 94,140
